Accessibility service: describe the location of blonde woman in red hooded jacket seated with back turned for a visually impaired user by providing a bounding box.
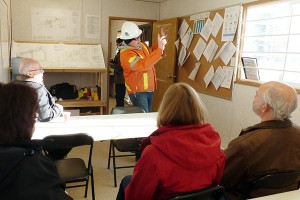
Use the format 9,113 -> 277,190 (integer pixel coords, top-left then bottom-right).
117,83 -> 225,200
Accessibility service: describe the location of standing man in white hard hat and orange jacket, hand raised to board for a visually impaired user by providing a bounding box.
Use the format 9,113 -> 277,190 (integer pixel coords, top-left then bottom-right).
119,22 -> 167,112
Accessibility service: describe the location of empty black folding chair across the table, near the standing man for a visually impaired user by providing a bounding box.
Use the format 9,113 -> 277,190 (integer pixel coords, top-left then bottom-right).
107,106 -> 145,187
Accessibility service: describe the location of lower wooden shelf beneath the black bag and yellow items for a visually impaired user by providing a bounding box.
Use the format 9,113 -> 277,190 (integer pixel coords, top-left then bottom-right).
56,100 -> 106,108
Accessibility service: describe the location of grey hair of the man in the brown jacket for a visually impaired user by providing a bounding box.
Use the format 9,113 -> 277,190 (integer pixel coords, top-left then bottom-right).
263,86 -> 297,120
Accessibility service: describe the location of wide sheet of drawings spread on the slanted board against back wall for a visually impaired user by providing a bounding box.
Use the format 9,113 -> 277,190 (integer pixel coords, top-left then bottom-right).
11,42 -> 105,68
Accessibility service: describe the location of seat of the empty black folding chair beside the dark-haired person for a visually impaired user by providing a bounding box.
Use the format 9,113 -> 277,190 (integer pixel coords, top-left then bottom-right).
54,158 -> 88,183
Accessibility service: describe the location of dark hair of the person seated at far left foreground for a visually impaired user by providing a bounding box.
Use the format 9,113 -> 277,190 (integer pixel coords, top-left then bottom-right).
0,82 -> 38,146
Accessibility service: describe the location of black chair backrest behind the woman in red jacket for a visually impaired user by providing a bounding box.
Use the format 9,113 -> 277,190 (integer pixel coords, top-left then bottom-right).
167,185 -> 224,200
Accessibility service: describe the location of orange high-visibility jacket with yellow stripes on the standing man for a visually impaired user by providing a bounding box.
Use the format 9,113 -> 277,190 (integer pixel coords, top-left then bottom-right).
120,42 -> 163,94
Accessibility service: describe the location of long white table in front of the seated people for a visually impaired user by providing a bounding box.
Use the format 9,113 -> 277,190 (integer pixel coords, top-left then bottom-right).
32,112 -> 157,141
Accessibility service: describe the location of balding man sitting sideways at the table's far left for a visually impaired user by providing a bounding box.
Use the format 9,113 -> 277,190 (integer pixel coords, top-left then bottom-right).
16,58 -> 71,159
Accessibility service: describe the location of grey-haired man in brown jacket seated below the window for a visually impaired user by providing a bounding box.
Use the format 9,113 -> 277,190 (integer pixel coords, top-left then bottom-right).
221,81 -> 300,199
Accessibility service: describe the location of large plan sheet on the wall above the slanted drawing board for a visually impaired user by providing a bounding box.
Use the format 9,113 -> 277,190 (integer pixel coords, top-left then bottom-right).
31,8 -> 81,41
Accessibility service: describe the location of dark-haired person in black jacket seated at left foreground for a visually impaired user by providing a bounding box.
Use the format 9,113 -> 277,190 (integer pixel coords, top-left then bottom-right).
0,82 -> 72,200
